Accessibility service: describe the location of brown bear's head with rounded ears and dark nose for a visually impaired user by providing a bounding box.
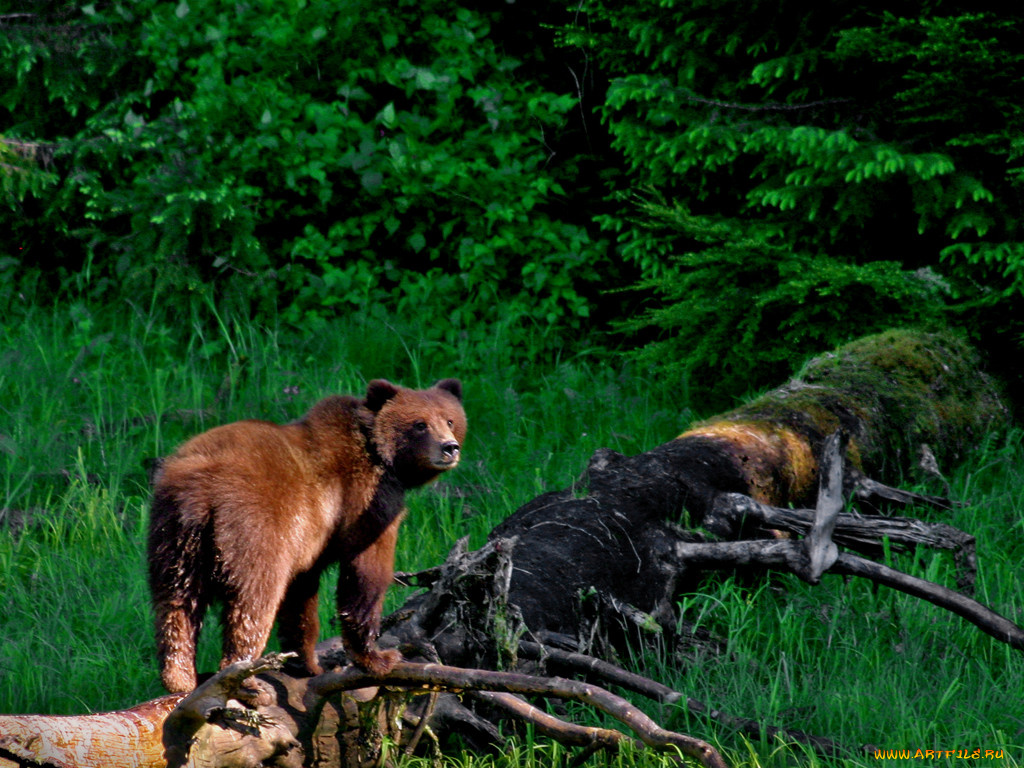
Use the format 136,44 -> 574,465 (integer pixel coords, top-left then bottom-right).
366,379 -> 466,487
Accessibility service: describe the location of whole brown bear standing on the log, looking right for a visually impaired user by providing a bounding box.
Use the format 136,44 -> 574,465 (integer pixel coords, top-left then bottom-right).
148,379 -> 466,692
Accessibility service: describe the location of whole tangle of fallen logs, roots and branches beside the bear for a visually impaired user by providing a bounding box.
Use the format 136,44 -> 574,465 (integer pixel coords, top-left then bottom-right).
0,333 -> 1024,768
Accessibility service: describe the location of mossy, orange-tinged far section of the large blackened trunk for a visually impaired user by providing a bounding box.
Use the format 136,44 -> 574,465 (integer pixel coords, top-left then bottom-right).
676,331 -> 1009,507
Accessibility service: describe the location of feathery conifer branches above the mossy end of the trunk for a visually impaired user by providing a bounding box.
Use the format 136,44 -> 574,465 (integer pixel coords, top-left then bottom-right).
564,0 -> 1024,403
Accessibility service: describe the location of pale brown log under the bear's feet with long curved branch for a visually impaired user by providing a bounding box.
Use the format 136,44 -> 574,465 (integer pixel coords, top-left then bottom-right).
0,654 -> 727,768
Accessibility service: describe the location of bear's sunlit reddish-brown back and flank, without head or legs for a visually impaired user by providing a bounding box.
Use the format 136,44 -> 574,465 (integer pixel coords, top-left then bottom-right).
154,397 -> 380,557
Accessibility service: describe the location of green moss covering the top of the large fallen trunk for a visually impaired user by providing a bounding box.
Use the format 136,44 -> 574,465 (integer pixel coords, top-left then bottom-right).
691,330 -> 1009,480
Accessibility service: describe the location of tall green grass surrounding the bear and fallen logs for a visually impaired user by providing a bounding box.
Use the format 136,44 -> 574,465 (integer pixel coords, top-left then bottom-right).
0,296 -> 1024,768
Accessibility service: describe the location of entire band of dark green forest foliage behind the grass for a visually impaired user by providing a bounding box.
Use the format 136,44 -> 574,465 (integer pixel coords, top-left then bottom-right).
0,0 -> 1024,404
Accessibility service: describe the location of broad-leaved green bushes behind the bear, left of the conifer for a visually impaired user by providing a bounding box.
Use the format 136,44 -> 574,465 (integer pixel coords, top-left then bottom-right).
0,0 -> 602,354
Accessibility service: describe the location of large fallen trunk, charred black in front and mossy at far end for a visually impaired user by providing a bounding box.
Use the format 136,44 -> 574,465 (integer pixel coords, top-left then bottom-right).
490,331 -> 1009,644
